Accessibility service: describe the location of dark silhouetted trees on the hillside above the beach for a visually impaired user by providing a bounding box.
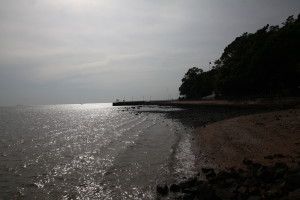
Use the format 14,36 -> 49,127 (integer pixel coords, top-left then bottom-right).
179,14 -> 300,99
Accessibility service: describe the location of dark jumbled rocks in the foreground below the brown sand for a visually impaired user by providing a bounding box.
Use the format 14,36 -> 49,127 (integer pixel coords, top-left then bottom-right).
156,159 -> 300,200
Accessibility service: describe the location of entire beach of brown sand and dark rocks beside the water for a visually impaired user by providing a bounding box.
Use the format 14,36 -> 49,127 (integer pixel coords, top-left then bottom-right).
157,106 -> 300,200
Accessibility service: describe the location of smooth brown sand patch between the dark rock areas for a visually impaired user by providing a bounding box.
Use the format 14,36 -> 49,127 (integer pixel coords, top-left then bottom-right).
192,108 -> 300,174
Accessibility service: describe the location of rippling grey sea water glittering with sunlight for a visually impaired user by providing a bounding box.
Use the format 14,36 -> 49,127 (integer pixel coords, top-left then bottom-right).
0,104 -> 194,199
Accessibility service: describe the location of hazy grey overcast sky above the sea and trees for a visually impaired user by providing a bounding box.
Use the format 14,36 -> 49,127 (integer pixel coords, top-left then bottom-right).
0,0 -> 300,106
